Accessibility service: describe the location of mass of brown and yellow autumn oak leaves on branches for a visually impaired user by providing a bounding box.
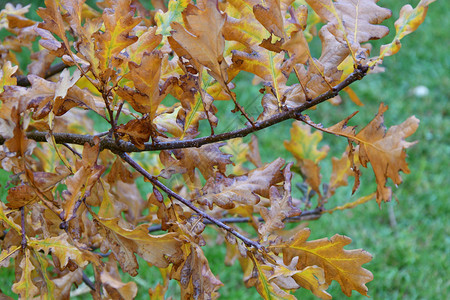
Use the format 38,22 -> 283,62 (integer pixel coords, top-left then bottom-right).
0,0 -> 433,299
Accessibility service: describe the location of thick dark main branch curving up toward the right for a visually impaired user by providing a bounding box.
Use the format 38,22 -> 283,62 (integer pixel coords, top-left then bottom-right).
0,66 -> 369,153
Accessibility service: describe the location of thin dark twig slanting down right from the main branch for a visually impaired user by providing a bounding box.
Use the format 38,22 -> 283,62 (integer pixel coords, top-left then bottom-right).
118,152 -> 263,250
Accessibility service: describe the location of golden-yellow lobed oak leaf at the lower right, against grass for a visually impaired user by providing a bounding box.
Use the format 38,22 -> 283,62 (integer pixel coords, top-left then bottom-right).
276,228 -> 373,297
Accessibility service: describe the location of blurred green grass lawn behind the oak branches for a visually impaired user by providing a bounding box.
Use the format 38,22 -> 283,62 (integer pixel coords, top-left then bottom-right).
0,0 -> 450,299
